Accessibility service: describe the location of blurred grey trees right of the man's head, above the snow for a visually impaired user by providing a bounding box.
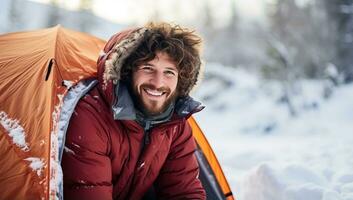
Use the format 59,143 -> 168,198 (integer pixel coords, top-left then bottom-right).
201,0 -> 353,84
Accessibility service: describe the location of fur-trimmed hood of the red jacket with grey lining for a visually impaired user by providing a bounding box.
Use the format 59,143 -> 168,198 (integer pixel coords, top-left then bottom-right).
97,27 -> 204,120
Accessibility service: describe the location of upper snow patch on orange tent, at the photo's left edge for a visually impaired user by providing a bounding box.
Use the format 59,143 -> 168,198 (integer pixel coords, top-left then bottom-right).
0,111 -> 29,151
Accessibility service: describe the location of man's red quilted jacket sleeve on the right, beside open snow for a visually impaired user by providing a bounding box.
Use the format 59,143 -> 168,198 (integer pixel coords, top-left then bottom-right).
155,119 -> 206,199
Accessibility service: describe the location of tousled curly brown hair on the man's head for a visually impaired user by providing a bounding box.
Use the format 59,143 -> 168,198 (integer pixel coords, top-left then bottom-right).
121,23 -> 201,97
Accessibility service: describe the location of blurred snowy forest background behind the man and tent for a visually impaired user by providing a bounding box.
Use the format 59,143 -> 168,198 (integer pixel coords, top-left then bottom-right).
0,0 -> 353,200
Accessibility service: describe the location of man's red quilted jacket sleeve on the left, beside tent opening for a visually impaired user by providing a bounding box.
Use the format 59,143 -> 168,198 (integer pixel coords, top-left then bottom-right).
62,101 -> 112,200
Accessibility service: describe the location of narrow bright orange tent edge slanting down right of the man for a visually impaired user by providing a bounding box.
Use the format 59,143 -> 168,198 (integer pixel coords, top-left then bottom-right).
188,117 -> 234,200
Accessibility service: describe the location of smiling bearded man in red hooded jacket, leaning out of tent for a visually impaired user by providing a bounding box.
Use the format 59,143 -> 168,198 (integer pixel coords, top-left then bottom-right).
62,23 -> 206,200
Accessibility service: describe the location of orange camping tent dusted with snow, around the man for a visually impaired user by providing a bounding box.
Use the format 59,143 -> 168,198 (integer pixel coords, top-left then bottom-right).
0,26 -> 234,199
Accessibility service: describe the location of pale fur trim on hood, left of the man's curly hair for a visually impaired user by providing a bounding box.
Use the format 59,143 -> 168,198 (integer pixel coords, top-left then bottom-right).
103,28 -> 148,85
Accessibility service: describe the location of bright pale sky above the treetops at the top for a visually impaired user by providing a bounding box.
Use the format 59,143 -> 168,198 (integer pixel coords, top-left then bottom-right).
32,0 -> 266,24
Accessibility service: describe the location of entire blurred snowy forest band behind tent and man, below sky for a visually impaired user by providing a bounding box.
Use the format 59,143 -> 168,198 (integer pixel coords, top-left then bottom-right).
0,0 -> 353,85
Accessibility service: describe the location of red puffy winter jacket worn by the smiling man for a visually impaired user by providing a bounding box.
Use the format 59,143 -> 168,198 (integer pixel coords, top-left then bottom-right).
62,27 -> 206,200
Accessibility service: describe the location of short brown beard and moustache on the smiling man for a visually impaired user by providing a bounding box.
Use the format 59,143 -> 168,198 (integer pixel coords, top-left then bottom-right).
131,84 -> 177,116
